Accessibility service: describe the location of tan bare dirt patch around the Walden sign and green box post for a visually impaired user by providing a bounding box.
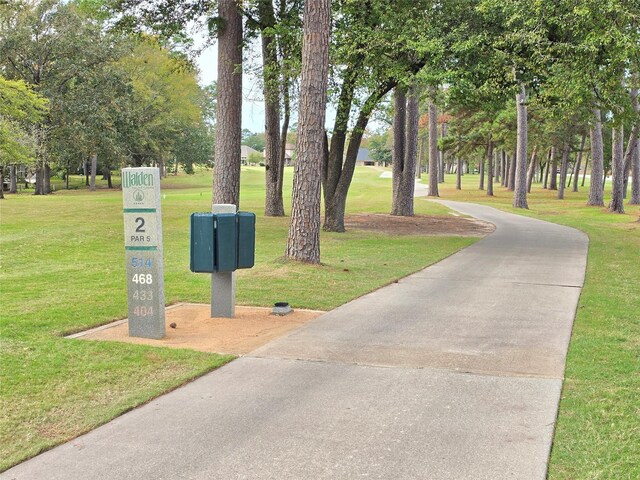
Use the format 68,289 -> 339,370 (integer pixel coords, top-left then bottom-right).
73,303 -> 324,355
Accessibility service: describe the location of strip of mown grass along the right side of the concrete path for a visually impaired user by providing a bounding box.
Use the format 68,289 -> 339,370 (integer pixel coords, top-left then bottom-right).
430,175 -> 640,480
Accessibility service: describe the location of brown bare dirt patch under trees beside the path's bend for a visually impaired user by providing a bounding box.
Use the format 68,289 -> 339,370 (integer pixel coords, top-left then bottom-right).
344,213 -> 495,237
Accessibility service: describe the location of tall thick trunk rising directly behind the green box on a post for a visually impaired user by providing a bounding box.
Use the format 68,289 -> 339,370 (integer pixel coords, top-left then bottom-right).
213,0 -> 242,206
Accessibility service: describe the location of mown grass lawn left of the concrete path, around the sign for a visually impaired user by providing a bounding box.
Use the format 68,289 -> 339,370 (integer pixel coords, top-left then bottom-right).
0,168 -> 476,471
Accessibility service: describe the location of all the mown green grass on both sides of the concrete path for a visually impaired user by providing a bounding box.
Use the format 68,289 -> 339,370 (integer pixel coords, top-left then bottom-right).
0,169 -> 640,480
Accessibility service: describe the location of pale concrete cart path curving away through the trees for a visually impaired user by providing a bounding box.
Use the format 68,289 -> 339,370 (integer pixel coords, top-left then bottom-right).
0,202 -> 588,480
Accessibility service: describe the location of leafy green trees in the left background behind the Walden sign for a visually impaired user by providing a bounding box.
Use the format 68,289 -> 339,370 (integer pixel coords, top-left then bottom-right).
0,0 -> 215,199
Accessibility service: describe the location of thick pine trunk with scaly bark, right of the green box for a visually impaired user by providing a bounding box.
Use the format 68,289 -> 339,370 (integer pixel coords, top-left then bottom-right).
286,0 -> 331,263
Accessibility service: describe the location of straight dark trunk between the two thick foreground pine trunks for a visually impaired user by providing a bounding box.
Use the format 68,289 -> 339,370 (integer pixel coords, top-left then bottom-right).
258,0 -> 284,217
